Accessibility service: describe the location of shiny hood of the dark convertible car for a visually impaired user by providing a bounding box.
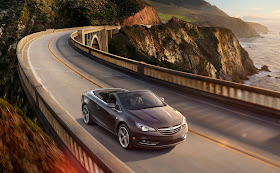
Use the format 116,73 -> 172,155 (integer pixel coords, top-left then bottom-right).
129,106 -> 183,128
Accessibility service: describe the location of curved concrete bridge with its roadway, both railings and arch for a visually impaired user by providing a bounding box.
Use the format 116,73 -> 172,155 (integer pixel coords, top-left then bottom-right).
17,27 -> 280,173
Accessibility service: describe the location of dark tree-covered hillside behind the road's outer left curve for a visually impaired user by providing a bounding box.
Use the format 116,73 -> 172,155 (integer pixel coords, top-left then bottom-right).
0,0 -> 156,122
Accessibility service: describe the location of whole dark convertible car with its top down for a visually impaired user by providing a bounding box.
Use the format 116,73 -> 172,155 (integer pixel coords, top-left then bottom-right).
81,88 -> 188,149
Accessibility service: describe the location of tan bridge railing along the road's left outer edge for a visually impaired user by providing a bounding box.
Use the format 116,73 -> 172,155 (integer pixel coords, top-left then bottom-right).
17,28 -> 132,173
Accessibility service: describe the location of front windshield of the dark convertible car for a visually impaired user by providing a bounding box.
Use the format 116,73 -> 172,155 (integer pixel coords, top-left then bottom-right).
117,91 -> 165,110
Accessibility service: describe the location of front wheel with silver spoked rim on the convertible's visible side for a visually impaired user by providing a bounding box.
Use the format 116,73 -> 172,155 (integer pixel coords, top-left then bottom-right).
118,124 -> 133,150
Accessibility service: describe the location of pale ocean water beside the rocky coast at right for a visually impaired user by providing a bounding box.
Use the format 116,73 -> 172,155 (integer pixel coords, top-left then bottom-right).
239,21 -> 280,92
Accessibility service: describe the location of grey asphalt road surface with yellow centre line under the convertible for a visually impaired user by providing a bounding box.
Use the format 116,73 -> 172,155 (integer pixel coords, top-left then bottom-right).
25,32 -> 280,173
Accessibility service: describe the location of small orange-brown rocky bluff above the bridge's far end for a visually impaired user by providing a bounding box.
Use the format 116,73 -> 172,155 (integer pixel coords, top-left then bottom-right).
123,6 -> 161,26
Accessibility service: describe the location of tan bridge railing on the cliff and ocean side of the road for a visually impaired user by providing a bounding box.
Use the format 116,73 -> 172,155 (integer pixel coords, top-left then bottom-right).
71,29 -> 280,114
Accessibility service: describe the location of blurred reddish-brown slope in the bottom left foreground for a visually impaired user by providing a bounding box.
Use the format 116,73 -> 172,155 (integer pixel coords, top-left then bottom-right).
0,98 -> 77,173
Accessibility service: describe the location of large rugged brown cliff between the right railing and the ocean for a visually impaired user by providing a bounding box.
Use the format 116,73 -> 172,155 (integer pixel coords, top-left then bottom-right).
109,17 -> 256,82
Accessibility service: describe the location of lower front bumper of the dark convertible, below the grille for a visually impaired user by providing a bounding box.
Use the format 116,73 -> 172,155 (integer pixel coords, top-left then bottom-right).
132,127 -> 188,148
